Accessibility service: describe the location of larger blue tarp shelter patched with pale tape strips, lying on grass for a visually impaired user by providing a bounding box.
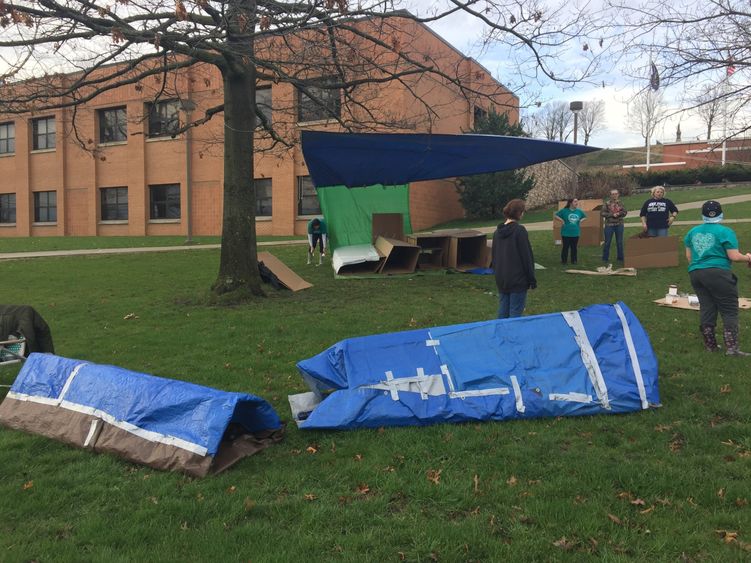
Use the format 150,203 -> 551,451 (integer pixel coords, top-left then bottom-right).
290,303 -> 659,429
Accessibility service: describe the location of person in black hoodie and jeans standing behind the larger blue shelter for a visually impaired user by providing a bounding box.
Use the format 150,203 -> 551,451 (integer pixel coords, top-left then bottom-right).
493,199 -> 537,319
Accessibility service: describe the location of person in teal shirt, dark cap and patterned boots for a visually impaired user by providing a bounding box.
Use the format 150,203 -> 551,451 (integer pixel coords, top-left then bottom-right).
683,200 -> 751,356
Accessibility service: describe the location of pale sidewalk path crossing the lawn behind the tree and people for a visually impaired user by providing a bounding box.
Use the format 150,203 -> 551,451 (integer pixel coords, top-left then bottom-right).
0,194 -> 751,260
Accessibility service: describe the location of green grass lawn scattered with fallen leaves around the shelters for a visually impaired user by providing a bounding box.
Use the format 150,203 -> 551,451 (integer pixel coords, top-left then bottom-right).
0,224 -> 751,562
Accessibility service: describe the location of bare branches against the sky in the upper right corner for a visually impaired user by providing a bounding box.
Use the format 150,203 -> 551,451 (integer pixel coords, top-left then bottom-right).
610,0 -> 751,137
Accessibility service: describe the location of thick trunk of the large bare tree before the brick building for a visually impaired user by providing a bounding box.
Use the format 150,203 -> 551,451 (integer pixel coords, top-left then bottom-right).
212,64 -> 264,295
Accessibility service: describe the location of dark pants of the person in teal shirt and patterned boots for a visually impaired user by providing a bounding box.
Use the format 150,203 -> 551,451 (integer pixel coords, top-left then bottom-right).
688,268 -> 738,330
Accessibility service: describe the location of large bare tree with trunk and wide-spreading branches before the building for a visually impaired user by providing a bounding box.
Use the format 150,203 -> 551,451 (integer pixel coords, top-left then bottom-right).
0,0 -> 608,294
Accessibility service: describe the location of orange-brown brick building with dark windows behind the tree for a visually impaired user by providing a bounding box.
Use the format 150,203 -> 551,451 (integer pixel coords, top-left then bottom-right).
0,18 -> 518,237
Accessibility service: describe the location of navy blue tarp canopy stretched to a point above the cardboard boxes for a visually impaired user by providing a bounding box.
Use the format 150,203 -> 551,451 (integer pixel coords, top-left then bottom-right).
302,131 -> 600,188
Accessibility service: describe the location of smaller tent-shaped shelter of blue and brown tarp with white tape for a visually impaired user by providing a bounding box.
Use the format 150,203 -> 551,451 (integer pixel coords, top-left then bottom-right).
0,354 -> 282,477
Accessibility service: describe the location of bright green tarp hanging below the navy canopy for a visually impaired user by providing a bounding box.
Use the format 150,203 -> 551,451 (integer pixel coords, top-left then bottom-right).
317,184 -> 412,250
